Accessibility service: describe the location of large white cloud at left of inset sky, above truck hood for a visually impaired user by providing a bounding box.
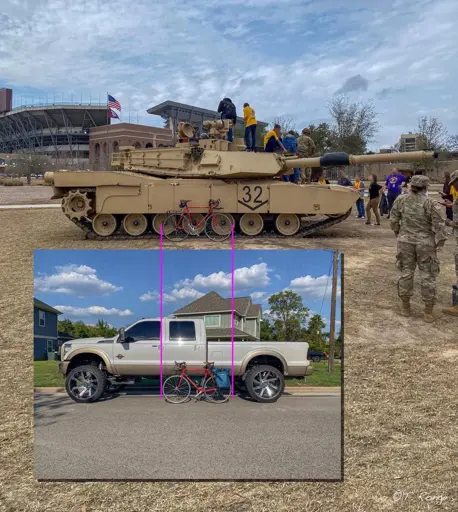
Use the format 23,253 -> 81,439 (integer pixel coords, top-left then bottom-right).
34,264 -> 122,297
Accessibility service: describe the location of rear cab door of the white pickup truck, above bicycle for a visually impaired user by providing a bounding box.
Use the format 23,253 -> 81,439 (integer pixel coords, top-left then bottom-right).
164,320 -> 207,375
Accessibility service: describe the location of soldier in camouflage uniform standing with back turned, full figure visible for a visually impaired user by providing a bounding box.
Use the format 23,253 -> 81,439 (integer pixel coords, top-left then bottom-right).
390,176 -> 447,322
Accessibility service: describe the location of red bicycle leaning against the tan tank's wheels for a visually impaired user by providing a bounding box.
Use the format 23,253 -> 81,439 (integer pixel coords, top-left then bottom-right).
163,199 -> 232,242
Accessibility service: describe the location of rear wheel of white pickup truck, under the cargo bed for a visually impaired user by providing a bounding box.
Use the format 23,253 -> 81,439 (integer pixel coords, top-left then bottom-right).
245,365 -> 285,403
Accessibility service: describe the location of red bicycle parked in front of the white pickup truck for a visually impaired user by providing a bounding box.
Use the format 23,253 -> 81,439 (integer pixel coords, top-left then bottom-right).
162,361 -> 231,404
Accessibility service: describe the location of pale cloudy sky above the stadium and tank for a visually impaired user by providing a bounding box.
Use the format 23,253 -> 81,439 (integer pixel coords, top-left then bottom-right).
0,0 -> 458,150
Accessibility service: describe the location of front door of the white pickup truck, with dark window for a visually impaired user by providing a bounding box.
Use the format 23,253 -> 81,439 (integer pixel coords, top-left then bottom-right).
113,320 -> 160,376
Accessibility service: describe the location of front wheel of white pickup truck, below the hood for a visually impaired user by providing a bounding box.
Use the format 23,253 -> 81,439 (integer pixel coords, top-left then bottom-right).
65,364 -> 107,404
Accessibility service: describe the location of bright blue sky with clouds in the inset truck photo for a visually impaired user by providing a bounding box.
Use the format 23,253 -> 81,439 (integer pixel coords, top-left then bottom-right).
34,250 -> 340,327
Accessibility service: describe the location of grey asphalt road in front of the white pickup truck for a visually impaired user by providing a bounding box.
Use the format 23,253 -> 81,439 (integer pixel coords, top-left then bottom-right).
35,394 -> 341,480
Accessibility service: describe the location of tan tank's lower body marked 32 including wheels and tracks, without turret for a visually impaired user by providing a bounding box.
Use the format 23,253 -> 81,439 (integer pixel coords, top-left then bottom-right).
52,171 -> 359,239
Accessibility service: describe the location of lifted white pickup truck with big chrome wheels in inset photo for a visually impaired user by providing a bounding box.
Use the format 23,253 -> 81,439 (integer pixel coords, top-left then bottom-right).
59,318 -> 312,403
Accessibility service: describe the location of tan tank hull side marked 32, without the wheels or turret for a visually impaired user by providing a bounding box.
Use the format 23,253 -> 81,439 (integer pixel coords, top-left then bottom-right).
50,171 -> 359,215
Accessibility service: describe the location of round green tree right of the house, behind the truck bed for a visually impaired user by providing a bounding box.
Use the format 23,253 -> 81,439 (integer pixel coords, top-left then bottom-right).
269,290 -> 309,341
